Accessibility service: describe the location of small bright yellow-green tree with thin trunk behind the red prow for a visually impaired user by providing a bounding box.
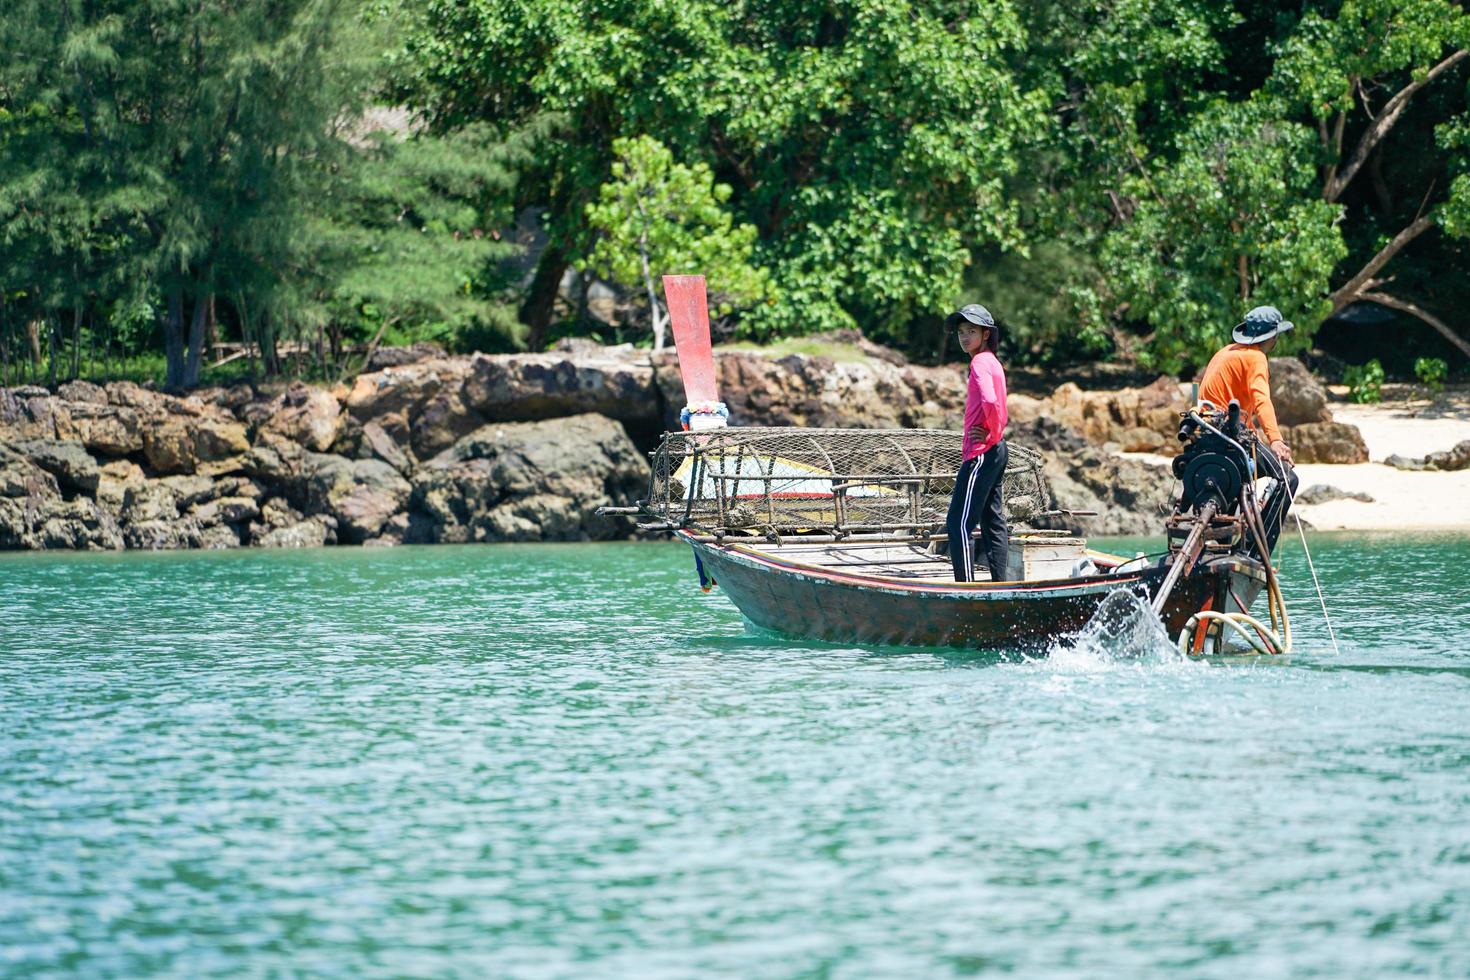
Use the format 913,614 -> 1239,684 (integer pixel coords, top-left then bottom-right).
587,137 -> 770,351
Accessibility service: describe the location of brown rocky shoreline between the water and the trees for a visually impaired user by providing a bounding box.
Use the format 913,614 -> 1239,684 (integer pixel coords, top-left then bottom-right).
0,339 -> 1367,550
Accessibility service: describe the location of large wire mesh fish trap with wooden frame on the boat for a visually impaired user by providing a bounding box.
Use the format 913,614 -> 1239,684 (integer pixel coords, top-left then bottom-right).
642,428 -> 1053,538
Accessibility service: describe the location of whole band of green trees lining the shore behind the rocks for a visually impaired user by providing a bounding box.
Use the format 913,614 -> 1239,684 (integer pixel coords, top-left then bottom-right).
0,0 -> 1470,385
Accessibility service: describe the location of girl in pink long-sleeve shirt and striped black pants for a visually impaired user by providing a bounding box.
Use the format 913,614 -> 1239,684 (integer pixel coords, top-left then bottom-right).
944,303 -> 1010,582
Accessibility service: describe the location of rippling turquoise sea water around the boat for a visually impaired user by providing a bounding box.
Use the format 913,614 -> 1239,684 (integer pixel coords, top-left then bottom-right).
0,536 -> 1470,977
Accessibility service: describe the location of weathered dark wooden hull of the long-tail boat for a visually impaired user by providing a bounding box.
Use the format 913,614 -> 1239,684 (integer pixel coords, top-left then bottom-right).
681,535 -> 1266,649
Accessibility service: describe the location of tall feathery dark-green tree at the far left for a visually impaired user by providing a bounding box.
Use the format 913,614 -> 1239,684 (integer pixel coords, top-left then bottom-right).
0,0 -> 363,388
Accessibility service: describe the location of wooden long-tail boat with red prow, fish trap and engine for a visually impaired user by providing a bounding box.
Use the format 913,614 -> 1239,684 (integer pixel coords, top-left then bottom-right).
606,276 -> 1279,651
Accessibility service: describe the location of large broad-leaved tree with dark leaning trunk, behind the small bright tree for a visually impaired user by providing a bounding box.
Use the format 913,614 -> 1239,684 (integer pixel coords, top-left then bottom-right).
385,0 -> 1048,345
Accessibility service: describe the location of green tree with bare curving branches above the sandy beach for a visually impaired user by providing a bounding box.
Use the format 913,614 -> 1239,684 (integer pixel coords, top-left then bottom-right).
1033,0 -> 1470,369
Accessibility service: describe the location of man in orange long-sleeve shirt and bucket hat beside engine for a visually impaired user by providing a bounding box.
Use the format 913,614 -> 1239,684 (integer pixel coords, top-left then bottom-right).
1200,306 -> 1297,555
